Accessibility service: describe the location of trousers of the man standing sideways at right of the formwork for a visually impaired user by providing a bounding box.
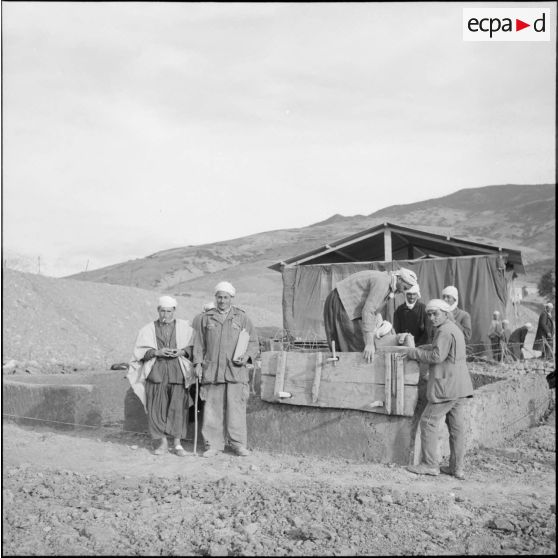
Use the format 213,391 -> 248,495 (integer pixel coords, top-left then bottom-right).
420,397 -> 468,471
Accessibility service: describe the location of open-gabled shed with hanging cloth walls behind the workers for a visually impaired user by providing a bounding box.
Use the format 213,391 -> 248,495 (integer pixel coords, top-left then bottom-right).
270,222 -> 525,354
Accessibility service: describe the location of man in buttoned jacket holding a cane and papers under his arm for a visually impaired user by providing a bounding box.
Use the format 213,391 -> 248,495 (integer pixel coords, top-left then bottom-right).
194,281 -> 259,457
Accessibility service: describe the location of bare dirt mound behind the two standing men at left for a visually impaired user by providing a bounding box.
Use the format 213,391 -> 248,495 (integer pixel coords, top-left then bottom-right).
2,269 -> 281,373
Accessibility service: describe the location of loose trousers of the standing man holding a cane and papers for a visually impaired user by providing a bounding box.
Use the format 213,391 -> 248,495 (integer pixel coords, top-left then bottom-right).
202,383 -> 250,451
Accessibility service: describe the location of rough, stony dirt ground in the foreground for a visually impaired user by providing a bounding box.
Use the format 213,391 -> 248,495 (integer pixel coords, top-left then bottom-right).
2,403 -> 556,556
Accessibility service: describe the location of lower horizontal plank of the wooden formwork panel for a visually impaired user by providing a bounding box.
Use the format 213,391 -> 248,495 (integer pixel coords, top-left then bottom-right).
261,376 -> 418,416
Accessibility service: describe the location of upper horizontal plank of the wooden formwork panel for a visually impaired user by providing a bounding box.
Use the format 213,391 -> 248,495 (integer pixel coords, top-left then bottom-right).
261,347 -> 419,385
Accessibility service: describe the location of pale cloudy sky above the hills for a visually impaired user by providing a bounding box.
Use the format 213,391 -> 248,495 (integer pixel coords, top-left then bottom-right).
2,2 -> 556,276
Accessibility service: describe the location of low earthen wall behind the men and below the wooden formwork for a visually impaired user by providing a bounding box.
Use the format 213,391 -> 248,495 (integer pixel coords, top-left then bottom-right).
2,371 -> 550,464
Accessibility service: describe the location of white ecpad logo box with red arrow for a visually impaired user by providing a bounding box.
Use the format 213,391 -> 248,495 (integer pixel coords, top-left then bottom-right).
463,8 -> 552,41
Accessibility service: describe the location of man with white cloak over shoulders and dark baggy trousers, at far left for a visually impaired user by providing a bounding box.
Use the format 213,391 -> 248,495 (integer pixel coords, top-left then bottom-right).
127,296 -> 195,457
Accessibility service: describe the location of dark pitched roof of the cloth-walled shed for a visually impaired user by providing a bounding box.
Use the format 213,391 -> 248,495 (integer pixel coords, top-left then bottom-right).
269,222 -> 525,273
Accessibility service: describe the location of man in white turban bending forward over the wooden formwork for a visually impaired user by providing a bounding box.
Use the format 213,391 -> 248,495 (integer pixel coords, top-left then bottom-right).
324,268 -> 417,362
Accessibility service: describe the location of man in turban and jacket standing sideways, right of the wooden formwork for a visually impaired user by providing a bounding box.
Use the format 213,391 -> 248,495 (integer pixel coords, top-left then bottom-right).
406,299 -> 473,479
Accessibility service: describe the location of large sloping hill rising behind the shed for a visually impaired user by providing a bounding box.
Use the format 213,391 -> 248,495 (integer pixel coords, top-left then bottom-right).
71,184 -> 556,302
